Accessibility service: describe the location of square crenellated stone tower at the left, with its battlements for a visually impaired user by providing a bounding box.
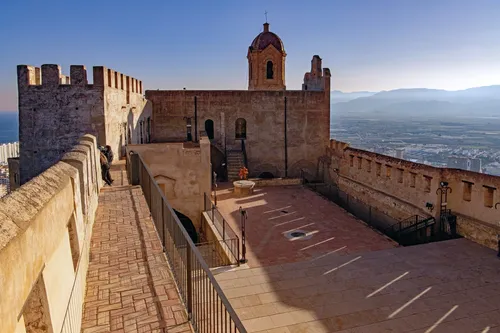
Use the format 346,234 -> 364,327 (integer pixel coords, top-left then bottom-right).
17,65 -> 147,184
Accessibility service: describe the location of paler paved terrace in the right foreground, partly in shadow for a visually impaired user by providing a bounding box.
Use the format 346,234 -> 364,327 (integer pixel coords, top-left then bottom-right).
216,239 -> 500,333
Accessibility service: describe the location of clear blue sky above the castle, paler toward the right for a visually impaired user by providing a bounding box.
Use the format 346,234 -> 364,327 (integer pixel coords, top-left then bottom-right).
0,0 -> 500,110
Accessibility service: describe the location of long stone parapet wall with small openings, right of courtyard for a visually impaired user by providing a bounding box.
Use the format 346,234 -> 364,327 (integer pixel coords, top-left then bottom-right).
324,140 -> 500,249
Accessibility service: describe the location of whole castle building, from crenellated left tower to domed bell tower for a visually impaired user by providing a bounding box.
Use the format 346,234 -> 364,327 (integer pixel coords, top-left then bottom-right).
13,23 -> 330,187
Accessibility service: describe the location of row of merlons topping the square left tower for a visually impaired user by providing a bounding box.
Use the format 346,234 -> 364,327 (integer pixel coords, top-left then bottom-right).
17,64 -> 144,94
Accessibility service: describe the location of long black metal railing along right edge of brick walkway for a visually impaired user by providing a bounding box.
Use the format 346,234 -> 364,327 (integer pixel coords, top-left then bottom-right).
129,155 -> 246,333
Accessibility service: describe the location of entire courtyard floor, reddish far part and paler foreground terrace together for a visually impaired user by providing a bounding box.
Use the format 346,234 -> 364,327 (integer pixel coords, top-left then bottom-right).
216,184 -> 500,333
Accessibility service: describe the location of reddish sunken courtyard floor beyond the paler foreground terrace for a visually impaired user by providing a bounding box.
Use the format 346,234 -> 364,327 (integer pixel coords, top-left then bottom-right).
217,186 -> 397,267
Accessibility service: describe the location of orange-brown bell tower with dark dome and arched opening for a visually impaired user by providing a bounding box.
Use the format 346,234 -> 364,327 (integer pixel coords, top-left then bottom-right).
247,22 -> 286,90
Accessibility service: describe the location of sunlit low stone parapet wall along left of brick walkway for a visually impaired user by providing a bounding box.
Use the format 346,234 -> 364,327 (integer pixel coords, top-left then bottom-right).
0,135 -> 102,333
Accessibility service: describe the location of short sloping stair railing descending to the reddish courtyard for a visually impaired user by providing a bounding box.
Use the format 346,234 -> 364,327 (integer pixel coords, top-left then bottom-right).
204,193 -> 240,265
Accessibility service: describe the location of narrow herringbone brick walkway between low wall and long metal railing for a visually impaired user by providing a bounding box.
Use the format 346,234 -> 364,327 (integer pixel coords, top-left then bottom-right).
82,163 -> 192,333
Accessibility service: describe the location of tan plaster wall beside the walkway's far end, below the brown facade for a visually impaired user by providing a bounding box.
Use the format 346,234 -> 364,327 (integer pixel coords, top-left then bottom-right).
127,137 -> 212,230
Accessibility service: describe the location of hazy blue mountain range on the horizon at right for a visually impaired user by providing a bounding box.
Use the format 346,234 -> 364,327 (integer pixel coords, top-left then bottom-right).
331,85 -> 500,118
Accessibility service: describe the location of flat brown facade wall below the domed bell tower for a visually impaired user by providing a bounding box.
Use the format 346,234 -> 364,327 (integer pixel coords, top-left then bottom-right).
146,86 -> 330,177
